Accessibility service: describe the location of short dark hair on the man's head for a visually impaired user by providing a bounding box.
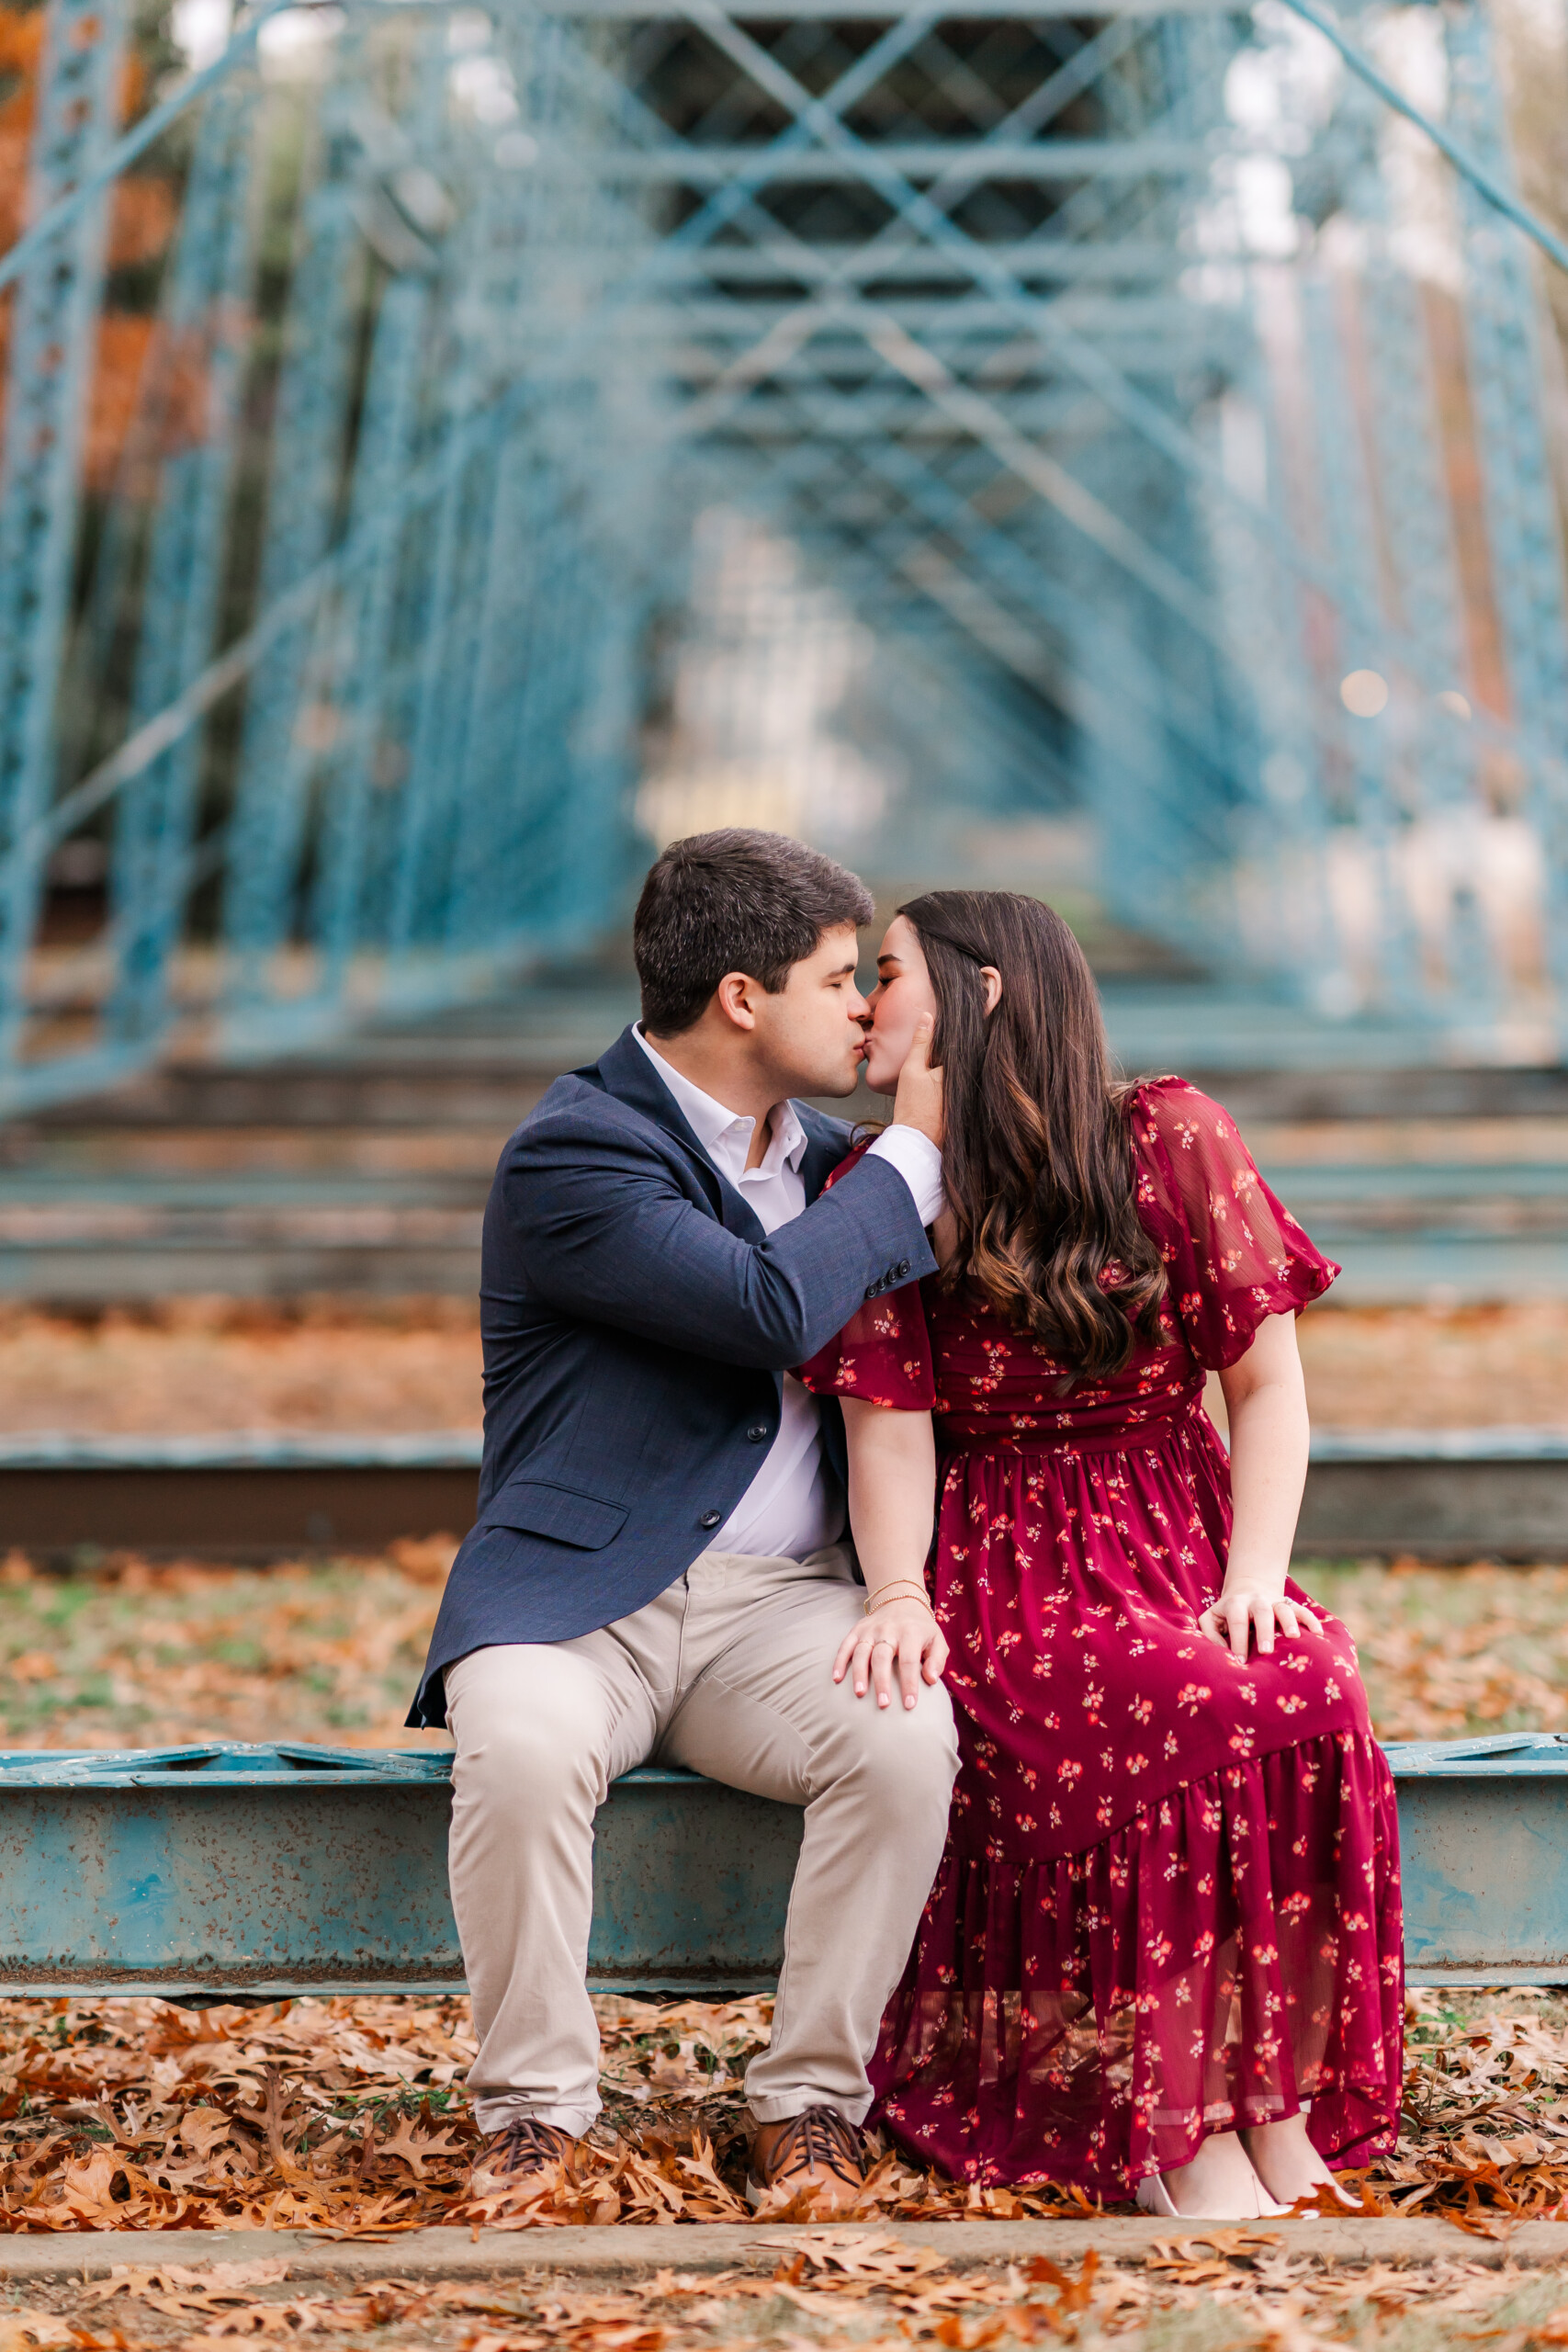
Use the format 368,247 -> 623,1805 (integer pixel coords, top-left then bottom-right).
632,826 -> 874,1037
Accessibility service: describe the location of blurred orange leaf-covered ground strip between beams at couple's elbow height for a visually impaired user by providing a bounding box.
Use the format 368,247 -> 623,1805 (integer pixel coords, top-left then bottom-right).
0,1298 -> 1568,1435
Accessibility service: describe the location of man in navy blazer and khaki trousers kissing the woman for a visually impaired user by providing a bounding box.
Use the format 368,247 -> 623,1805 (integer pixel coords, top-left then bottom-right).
409,831 -> 957,2211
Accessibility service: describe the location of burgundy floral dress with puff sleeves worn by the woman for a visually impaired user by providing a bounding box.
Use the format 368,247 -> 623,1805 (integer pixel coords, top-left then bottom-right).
802,1077 -> 1404,2199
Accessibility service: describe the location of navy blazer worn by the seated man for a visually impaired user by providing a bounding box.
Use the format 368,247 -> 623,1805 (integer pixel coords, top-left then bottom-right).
409,1030 -> 936,1724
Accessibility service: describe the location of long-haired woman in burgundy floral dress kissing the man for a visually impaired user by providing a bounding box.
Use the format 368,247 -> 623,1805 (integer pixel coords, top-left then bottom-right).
804,891 -> 1404,2218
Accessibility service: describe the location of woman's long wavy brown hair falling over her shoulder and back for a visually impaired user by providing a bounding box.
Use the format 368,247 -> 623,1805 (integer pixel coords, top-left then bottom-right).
898,889 -> 1166,1376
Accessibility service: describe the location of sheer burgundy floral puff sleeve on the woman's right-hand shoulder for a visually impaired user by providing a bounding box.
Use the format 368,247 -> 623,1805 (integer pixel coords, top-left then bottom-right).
1131,1077 -> 1340,1371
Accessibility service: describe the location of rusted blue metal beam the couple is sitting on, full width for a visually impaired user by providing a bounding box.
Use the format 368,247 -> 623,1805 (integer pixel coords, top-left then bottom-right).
0,1734 -> 1568,1999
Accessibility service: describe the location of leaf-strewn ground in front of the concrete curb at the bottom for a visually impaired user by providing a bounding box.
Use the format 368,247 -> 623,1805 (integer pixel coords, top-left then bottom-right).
21,2230 -> 1568,2352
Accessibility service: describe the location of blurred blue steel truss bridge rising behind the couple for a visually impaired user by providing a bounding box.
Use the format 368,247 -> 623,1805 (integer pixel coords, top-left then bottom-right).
0,0 -> 1568,1113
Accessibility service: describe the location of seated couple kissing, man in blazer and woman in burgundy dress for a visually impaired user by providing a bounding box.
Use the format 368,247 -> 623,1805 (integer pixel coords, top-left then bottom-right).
409,831 -> 1404,2218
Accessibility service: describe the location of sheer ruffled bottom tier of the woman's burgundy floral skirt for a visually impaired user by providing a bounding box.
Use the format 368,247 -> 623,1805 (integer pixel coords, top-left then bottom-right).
872,1731 -> 1404,2199
